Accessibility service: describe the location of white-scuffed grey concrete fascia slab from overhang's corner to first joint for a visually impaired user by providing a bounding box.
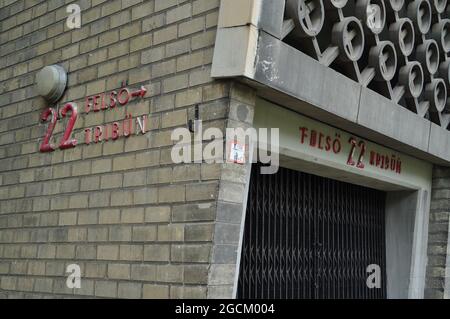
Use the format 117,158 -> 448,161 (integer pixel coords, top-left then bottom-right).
254,32 -> 361,122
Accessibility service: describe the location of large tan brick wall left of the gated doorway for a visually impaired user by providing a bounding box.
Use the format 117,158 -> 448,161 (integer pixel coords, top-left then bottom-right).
0,0 -> 245,298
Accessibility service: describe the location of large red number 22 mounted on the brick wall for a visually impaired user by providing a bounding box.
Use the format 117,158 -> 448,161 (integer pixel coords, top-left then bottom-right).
39,103 -> 78,153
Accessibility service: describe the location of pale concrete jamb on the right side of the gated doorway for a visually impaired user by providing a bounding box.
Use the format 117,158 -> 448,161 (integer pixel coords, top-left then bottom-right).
386,188 -> 430,299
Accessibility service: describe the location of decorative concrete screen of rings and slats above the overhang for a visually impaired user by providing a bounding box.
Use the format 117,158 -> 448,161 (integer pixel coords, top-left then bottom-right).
282,0 -> 450,129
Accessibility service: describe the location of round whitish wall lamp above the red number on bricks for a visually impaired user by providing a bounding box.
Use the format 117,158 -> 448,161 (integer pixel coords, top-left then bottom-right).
36,65 -> 67,103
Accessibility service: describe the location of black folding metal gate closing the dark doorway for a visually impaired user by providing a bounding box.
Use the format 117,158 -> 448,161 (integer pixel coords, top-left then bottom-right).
237,165 -> 386,299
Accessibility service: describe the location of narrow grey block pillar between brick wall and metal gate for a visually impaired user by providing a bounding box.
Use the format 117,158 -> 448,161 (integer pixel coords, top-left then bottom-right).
207,83 -> 256,299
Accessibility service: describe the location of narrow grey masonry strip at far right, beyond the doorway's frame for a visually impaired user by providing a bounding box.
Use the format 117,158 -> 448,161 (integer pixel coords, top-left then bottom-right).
425,166 -> 450,299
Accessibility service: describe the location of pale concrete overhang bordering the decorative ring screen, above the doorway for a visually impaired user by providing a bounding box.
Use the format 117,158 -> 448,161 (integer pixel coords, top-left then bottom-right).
212,0 -> 450,166
